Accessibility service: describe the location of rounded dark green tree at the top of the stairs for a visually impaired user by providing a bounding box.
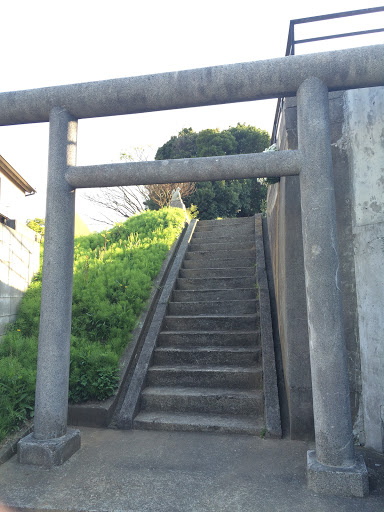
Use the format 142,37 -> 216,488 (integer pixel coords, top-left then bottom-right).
155,123 -> 270,219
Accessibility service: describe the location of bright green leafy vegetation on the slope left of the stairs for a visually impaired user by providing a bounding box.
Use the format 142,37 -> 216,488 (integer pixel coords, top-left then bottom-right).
0,208 -> 185,441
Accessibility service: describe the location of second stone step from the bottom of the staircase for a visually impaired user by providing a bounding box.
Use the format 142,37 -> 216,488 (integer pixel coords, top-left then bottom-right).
141,386 -> 264,416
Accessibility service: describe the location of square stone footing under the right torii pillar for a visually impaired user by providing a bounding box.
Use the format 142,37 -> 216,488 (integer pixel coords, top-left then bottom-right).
307,450 -> 369,497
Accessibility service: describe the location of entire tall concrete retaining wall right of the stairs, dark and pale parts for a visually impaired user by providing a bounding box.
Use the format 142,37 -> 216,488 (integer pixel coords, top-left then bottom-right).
267,88 -> 384,451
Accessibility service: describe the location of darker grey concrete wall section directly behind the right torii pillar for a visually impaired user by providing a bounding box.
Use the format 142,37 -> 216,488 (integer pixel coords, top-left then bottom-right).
267,92 -> 364,440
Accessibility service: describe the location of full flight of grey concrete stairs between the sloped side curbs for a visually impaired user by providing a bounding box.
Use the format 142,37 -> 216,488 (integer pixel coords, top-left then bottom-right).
134,218 -> 264,435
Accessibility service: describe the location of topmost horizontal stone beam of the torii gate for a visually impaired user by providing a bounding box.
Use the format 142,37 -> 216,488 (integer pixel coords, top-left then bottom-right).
0,45 -> 384,125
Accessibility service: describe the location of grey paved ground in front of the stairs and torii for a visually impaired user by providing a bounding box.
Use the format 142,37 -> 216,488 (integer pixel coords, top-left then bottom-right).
0,428 -> 384,512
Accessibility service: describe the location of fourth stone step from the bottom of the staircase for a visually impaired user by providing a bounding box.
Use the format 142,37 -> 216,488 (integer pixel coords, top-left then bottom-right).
153,346 -> 261,366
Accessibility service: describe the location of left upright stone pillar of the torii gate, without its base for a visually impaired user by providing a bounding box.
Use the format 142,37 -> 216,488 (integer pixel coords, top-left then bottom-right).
32,107 -> 77,448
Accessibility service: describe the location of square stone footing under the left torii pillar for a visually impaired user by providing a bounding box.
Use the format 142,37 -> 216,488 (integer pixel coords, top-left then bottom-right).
17,430 -> 81,468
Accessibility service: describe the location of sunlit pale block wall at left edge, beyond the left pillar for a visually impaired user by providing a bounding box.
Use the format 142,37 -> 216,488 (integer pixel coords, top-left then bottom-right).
0,221 -> 40,339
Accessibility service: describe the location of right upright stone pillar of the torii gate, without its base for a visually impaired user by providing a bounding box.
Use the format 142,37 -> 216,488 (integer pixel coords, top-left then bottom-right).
297,78 -> 354,466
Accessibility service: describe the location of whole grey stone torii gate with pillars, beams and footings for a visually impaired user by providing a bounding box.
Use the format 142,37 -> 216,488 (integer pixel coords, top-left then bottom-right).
0,45 -> 384,496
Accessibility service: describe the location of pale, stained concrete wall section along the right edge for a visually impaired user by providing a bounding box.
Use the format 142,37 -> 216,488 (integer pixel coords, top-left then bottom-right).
344,87 -> 384,451
